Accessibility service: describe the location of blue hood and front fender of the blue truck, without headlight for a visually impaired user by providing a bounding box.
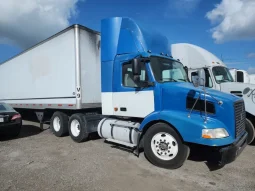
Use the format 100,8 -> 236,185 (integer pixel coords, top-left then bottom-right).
139,82 -> 240,146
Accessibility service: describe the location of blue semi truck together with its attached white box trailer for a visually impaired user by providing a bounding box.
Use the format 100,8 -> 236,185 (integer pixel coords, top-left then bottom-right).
0,17 -> 247,169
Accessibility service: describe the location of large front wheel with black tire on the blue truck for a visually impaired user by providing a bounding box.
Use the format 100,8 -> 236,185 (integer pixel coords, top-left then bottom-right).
144,123 -> 190,169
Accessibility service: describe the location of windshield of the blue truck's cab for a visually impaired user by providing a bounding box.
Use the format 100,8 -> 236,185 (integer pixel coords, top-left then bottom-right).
150,57 -> 188,83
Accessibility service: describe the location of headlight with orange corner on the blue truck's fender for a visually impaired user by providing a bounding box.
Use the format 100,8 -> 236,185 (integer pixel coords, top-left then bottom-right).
202,128 -> 229,139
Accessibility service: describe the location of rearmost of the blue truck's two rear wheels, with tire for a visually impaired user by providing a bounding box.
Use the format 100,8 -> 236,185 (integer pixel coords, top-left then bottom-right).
50,111 -> 68,137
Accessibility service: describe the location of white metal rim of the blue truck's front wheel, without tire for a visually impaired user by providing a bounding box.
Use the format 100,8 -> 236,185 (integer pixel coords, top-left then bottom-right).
151,132 -> 178,160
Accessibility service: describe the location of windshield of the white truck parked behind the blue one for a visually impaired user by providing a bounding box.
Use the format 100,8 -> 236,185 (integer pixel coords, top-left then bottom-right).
212,66 -> 234,84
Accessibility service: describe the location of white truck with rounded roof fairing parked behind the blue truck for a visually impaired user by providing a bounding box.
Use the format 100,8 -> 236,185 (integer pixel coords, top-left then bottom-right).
171,43 -> 255,144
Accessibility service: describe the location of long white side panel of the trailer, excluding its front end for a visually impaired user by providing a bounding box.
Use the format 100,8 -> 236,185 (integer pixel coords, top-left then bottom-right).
0,28 -> 76,108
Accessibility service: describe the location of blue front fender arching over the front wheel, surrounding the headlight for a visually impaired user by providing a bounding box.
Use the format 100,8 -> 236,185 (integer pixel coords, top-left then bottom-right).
140,110 -> 238,146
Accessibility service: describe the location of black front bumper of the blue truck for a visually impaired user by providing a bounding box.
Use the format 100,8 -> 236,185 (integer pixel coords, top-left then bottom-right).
219,133 -> 248,165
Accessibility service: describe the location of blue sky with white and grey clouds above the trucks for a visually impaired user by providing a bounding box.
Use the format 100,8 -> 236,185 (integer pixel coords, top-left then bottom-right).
0,0 -> 255,74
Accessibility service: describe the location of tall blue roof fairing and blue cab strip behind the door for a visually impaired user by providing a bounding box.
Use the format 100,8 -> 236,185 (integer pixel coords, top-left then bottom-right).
101,17 -> 170,92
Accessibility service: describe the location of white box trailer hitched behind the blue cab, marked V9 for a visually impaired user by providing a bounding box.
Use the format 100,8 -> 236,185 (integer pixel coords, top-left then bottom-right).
0,25 -> 101,130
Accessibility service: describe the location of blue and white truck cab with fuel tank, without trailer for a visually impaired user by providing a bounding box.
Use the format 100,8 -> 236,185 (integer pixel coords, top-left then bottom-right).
98,17 -> 247,169
